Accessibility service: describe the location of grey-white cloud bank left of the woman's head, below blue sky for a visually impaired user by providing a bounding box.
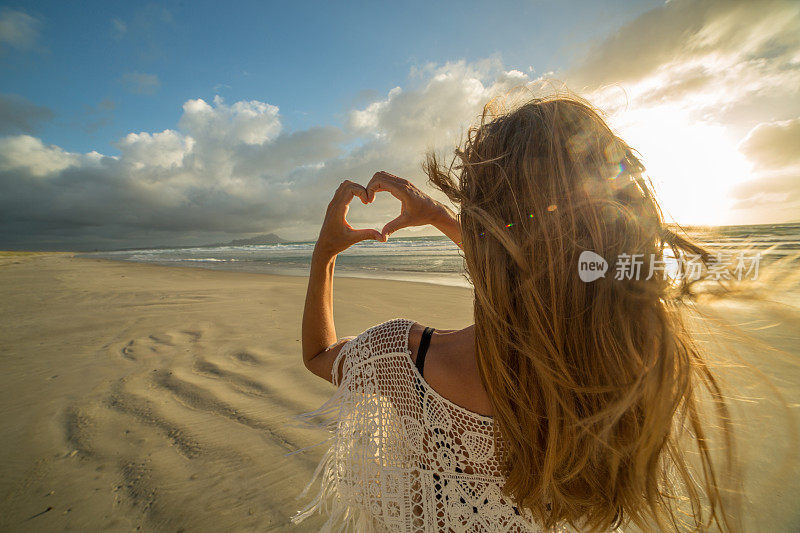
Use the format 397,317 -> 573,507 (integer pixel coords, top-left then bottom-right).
0,62 -> 520,249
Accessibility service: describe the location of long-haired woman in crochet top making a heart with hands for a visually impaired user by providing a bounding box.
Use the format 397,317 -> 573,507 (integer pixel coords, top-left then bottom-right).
297,97 -> 732,531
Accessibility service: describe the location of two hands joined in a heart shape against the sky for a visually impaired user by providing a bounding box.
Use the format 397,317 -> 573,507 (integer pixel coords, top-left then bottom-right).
317,171 -> 451,255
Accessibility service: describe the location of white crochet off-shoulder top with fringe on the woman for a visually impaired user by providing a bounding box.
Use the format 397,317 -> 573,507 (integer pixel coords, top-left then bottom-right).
292,319 -> 566,532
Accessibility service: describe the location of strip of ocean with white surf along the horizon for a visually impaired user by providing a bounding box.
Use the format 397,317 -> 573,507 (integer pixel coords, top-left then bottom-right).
81,223 -> 800,294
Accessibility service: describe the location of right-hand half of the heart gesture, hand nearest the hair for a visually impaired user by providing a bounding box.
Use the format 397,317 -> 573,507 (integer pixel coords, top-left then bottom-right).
366,171 -> 455,241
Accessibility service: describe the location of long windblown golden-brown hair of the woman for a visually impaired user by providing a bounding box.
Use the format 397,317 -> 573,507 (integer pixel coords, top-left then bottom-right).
424,96 -> 734,530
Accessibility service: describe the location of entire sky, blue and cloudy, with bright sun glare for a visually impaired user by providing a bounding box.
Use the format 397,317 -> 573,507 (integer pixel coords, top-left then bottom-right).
0,0 -> 800,249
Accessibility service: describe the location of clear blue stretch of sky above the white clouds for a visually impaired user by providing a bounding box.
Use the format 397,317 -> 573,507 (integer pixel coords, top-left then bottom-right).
0,1 -> 659,154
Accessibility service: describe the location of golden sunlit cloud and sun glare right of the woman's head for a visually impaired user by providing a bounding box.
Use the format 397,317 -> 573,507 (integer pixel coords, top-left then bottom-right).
568,0 -> 800,224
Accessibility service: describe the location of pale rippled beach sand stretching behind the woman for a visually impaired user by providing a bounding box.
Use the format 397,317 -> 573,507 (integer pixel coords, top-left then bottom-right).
0,254 -> 800,531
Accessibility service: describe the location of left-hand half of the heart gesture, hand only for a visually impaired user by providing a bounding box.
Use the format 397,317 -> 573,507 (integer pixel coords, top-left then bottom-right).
314,180 -> 382,257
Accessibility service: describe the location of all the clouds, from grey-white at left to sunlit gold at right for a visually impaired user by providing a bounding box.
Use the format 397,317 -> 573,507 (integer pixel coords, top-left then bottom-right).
0,0 -> 800,249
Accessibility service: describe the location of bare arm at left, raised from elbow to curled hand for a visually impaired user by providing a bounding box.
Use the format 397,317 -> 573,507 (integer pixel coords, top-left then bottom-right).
303,181 -> 382,381
